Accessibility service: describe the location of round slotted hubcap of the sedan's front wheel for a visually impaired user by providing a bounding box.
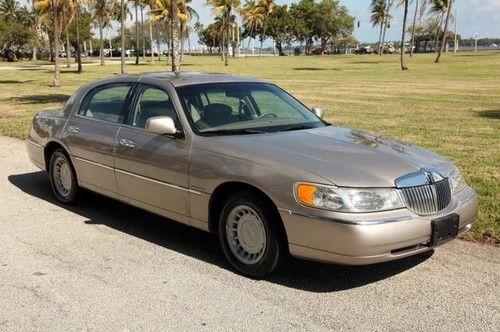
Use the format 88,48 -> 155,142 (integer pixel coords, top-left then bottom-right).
226,205 -> 266,265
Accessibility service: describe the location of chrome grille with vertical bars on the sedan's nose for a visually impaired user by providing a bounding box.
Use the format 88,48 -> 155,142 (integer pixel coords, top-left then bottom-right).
400,179 -> 451,215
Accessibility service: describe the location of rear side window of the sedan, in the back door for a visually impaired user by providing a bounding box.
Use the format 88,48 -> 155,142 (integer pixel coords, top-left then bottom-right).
78,83 -> 132,123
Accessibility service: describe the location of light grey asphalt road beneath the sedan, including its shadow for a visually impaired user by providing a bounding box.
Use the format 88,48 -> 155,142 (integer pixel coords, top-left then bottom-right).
0,137 -> 500,331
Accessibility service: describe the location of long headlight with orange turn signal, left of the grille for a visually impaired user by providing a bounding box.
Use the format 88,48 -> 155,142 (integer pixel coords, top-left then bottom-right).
295,183 -> 404,212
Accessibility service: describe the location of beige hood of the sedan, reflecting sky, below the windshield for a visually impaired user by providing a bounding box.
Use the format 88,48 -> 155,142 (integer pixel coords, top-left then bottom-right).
200,126 -> 453,187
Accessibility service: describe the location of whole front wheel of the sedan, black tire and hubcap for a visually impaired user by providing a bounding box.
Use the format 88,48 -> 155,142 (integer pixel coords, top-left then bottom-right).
219,193 -> 283,279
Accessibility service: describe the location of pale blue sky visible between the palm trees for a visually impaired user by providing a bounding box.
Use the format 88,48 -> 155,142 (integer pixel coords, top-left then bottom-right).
192,0 -> 500,43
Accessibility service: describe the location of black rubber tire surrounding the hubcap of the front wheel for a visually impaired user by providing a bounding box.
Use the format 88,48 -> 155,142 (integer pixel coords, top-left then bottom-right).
218,192 -> 285,279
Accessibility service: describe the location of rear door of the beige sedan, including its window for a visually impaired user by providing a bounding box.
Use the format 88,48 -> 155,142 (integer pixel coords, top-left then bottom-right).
65,83 -> 134,193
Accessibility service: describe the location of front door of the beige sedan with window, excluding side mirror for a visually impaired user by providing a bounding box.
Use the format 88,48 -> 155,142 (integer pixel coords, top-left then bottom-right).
115,84 -> 190,223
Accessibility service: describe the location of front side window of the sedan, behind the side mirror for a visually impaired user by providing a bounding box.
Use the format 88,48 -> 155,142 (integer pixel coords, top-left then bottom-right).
130,85 -> 180,128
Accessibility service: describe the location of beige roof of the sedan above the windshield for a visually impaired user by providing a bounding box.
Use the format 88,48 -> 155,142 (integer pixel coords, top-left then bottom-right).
142,72 -> 264,87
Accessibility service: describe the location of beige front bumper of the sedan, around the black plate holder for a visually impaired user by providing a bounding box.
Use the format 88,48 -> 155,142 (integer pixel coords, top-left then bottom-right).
279,188 -> 479,265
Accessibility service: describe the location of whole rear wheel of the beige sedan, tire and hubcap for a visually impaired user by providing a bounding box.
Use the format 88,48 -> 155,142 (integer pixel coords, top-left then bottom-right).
49,149 -> 78,204
